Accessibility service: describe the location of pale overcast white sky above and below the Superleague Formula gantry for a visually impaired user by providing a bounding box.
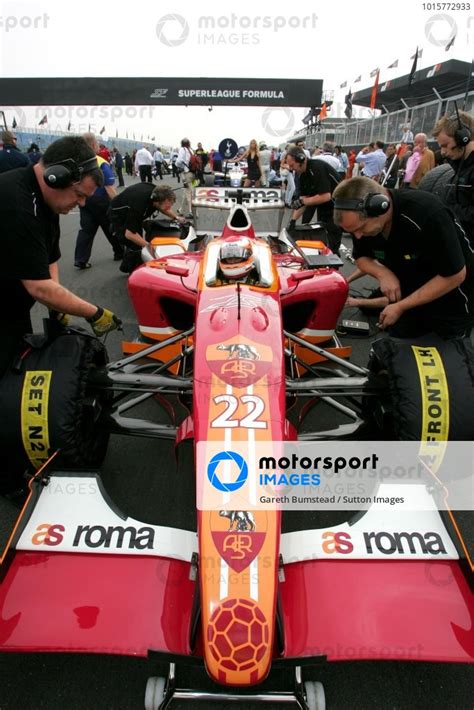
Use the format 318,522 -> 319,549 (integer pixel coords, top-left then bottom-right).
0,0 -> 474,148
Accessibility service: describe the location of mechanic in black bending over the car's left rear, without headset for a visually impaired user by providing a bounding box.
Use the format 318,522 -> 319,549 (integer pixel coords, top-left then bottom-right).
109,182 -> 186,273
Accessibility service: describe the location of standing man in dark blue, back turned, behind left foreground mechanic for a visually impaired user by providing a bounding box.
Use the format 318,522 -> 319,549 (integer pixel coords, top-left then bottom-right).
74,133 -> 123,271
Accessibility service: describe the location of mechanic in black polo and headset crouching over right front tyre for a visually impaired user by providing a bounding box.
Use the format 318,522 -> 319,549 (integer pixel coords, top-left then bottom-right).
334,177 -> 474,339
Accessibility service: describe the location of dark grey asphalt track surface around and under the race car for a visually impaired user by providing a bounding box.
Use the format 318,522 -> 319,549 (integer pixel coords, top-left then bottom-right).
0,178 -> 474,710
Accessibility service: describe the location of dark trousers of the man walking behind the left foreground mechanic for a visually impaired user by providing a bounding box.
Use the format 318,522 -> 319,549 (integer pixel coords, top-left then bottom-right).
74,196 -> 123,264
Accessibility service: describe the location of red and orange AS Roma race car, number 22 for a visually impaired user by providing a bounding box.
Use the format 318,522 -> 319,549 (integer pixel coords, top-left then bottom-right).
0,188 -> 474,710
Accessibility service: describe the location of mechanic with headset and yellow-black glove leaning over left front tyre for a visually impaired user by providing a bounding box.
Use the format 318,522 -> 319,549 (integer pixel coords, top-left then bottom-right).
0,136 -> 124,373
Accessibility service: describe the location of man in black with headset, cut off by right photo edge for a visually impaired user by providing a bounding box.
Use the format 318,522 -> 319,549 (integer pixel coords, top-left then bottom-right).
433,111 -> 474,244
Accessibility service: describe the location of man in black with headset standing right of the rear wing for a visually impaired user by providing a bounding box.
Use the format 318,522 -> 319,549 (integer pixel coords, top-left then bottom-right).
286,146 -> 342,254
